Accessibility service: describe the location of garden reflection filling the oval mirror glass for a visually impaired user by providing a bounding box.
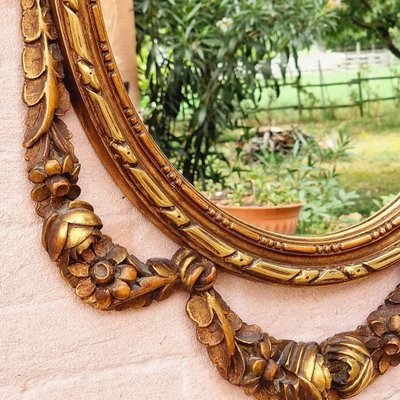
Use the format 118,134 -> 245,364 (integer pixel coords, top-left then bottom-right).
102,0 -> 400,235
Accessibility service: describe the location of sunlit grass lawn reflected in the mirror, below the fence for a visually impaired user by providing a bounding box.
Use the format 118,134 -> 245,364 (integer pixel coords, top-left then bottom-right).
299,109 -> 400,216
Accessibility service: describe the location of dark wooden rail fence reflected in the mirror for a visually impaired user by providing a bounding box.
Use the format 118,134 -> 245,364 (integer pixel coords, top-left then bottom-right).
265,72 -> 400,118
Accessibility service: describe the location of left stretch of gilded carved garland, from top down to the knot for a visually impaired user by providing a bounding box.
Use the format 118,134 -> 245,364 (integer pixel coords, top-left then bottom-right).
21,0 -> 183,316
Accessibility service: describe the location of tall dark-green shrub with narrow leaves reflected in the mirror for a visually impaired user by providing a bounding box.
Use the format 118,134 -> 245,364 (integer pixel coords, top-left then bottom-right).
135,0 -> 334,183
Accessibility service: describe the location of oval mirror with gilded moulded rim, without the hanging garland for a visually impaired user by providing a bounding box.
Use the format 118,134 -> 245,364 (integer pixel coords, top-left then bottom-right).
54,0 -> 400,285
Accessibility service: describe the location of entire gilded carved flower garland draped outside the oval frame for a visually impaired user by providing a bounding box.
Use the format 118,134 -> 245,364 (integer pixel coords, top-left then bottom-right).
21,0 -> 400,400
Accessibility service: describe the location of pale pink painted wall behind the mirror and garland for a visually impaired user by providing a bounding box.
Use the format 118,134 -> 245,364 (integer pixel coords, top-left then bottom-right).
0,0 -> 400,400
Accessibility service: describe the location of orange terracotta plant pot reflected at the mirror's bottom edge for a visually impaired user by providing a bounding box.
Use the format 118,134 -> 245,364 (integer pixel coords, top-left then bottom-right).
221,203 -> 304,235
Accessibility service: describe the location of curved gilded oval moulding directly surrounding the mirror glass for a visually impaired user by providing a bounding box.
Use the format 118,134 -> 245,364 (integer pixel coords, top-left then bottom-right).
45,0 -> 400,285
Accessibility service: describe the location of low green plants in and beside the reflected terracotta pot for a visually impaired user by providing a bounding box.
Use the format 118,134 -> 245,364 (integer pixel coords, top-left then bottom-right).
203,128 -> 361,234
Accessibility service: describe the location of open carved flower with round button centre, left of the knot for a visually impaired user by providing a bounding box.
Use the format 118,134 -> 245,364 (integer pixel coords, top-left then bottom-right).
68,238 -> 137,310
